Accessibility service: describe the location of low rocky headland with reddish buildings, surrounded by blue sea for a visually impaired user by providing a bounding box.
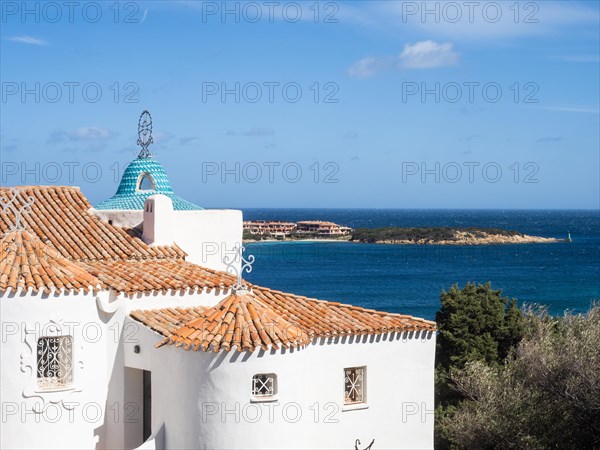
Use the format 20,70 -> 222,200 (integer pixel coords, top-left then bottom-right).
244,220 -> 565,245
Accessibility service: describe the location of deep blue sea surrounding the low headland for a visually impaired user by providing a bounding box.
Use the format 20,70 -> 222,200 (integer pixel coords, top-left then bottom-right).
244,209 -> 600,319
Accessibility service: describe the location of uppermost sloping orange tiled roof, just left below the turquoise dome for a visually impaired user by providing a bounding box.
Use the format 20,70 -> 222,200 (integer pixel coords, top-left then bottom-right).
0,186 -> 185,261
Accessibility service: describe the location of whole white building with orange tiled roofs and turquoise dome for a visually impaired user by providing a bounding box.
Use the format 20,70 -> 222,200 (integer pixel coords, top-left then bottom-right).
0,112 -> 435,450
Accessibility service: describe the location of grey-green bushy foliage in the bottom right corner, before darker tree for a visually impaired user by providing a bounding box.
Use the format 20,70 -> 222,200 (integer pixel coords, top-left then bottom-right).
438,303 -> 600,449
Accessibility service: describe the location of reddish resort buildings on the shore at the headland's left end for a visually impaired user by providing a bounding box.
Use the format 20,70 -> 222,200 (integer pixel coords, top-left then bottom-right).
244,220 -> 352,238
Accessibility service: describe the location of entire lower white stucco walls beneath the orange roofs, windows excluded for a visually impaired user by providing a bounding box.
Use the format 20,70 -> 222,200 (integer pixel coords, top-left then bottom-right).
0,264 -> 435,449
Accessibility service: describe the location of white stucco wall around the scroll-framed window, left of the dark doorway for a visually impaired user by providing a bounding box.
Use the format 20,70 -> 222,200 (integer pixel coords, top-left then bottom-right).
0,289 -> 239,449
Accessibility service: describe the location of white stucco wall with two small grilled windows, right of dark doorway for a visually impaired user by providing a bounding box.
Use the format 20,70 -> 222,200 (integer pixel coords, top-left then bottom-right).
124,320 -> 435,449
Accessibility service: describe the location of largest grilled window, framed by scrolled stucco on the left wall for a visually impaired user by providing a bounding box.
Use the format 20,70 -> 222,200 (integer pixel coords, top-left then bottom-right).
37,336 -> 73,389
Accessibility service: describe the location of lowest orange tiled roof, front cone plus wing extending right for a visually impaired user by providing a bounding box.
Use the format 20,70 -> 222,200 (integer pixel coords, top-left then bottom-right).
131,286 -> 435,351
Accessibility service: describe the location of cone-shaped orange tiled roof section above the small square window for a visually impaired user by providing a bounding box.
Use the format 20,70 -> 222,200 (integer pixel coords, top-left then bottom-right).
163,292 -> 310,352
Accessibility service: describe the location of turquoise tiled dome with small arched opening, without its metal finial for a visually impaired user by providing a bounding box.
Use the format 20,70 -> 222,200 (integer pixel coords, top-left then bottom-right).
95,157 -> 202,210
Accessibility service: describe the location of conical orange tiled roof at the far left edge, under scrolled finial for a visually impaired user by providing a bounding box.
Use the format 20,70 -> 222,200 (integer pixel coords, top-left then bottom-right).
0,230 -> 100,292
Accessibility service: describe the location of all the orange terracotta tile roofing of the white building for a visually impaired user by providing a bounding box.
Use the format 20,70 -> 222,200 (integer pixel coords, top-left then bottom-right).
0,186 -> 435,342
